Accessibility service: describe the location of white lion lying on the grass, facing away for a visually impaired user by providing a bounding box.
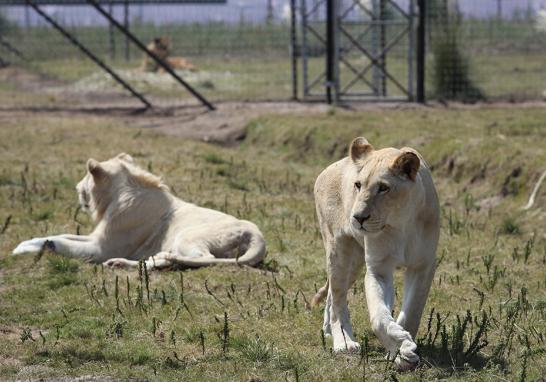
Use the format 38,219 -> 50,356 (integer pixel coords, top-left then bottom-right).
13,154 -> 266,269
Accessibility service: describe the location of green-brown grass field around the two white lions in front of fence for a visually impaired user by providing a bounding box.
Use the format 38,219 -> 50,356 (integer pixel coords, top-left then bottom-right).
0,107 -> 546,381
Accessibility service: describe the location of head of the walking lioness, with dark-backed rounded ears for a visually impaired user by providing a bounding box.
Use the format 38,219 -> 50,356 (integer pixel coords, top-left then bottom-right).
349,137 -> 420,234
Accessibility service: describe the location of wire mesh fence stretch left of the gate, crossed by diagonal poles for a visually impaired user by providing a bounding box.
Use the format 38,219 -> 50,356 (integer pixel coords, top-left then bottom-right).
0,0 -> 291,107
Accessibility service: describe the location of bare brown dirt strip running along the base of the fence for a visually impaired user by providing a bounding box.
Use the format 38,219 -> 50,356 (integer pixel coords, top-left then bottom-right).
0,66 -> 546,146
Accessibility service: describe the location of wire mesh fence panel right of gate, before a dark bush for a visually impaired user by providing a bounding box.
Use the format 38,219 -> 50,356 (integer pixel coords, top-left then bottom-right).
427,0 -> 546,101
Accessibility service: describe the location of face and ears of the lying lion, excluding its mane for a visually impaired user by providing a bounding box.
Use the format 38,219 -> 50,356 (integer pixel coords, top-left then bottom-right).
76,153 -> 132,220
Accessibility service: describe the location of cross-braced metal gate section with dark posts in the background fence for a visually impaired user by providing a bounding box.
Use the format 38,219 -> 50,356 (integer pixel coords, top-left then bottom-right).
293,0 -> 417,102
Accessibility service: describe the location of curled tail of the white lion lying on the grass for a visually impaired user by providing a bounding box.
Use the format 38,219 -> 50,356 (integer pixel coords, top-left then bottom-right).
172,222 -> 266,268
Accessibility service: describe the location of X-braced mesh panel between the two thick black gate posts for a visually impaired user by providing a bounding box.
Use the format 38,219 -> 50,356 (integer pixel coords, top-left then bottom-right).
338,0 -> 415,99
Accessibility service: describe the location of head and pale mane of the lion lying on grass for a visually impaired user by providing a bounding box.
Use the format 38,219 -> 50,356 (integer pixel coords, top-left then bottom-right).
76,153 -> 165,221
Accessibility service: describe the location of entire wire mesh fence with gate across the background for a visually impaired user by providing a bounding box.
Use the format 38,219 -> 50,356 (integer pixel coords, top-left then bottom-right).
0,0 -> 546,107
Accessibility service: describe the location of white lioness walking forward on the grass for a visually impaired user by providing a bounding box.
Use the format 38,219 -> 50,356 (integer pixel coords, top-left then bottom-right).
313,138 -> 440,370
